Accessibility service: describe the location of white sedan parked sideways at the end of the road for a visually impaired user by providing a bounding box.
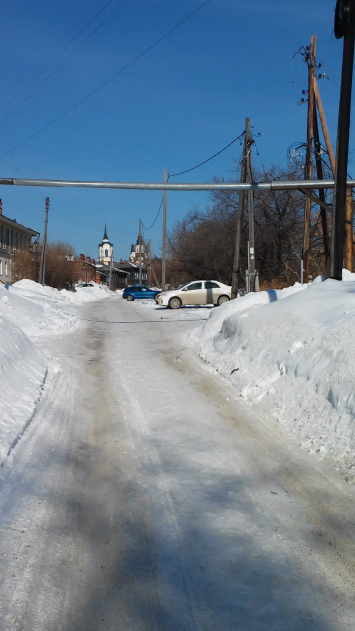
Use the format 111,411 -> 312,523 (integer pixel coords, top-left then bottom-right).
155,280 -> 232,309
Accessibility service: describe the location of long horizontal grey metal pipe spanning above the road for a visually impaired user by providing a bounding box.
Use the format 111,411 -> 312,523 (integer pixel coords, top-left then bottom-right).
0,178 -> 355,191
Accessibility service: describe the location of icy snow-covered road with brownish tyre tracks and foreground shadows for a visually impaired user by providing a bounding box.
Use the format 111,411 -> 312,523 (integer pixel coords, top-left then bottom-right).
0,296 -> 355,631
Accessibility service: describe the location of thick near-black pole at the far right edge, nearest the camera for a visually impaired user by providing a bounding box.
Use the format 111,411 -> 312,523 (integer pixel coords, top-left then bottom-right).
330,0 -> 355,280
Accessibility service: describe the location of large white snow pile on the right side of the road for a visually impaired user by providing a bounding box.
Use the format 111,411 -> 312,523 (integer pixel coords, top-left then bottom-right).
190,272 -> 355,474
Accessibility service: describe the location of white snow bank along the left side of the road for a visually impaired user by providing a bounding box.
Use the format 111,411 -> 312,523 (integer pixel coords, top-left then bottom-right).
0,280 -> 112,464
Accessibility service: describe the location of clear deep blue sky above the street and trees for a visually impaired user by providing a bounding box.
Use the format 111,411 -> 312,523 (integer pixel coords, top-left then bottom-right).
0,0 -> 355,260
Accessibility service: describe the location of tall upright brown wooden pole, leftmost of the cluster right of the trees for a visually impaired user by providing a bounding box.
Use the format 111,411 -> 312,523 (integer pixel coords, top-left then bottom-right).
303,35 -> 316,283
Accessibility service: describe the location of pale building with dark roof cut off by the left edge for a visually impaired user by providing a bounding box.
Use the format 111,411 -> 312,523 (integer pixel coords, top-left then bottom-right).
0,199 -> 39,283
